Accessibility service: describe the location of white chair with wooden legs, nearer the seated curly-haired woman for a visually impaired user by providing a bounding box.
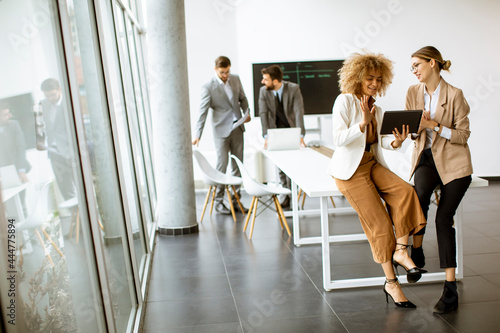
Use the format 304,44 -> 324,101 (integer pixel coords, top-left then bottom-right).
231,155 -> 292,239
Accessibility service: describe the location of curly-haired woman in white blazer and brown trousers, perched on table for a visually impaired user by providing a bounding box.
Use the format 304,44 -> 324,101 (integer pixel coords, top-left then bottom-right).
329,53 -> 426,308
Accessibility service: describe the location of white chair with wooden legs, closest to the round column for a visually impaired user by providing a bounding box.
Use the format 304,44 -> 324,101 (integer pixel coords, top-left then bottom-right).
193,150 -> 245,222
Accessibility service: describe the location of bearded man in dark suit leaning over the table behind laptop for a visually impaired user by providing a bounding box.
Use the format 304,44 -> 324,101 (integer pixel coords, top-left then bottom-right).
259,65 -> 306,208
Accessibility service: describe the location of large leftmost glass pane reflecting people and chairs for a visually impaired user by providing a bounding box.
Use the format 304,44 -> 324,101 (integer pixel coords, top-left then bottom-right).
0,0 -> 106,332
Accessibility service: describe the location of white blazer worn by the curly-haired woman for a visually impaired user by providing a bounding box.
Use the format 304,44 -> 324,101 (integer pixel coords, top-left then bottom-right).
328,94 -> 394,180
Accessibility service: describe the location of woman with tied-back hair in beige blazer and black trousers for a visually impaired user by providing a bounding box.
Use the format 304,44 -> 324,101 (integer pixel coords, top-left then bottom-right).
406,46 -> 472,313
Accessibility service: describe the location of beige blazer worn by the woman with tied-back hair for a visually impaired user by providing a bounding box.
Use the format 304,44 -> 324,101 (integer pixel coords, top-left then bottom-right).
406,78 -> 472,185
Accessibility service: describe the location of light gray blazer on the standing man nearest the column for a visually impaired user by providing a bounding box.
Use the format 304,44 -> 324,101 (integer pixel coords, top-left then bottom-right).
195,74 -> 248,138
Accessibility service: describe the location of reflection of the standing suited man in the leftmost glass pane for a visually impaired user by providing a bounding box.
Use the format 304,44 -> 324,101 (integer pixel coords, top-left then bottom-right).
40,79 -> 76,200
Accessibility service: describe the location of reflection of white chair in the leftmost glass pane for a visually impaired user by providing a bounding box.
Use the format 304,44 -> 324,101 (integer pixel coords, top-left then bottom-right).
16,180 -> 64,265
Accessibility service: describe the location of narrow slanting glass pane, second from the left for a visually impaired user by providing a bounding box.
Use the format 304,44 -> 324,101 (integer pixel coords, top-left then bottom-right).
68,1 -> 142,332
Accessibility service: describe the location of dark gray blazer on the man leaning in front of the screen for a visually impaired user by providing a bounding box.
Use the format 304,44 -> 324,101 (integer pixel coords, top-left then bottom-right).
259,81 -> 306,136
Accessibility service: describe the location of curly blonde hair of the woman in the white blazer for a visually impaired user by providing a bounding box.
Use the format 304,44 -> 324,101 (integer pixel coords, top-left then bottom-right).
339,53 -> 394,96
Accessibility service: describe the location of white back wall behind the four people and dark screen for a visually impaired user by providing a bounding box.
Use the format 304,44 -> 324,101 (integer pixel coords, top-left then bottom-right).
186,0 -> 500,176
